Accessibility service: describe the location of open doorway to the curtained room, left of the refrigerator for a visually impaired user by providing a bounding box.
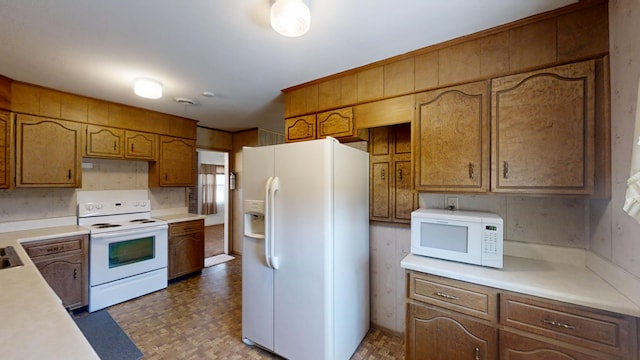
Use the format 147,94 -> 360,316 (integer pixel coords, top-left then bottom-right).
198,149 -> 230,266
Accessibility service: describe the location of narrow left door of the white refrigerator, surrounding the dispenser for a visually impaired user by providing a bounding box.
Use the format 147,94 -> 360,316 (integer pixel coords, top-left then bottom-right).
239,146 -> 274,351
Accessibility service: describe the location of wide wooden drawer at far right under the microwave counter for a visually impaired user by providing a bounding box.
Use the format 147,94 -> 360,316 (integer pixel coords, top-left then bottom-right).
500,293 -> 636,355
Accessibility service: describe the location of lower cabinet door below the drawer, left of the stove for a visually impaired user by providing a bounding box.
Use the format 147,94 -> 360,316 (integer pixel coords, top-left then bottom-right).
34,253 -> 89,309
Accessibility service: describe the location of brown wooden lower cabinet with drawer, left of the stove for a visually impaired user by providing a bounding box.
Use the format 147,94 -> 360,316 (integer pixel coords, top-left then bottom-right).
22,235 -> 89,309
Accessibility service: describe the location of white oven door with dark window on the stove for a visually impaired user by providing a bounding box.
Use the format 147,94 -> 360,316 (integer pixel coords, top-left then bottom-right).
89,224 -> 168,286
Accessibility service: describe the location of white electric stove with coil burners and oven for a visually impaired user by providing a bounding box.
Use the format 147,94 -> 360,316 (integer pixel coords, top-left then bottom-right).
78,190 -> 168,312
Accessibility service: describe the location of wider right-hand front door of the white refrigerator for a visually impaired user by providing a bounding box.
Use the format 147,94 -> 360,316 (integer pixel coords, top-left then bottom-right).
272,140 -> 333,360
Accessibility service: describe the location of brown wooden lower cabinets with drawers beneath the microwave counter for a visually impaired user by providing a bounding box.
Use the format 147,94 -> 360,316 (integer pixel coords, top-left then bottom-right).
405,271 -> 639,360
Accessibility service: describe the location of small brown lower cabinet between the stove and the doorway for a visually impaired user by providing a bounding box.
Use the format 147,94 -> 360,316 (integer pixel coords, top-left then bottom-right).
168,220 -> 204,279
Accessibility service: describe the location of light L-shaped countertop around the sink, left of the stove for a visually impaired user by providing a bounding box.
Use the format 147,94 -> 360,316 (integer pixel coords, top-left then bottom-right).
0,225 -> 98,359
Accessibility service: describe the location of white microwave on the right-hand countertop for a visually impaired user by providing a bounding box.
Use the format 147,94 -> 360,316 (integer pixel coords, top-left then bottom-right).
411,209 -> 504,269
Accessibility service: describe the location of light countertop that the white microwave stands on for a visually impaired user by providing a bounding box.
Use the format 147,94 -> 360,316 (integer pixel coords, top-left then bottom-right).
401,254 -> 640,317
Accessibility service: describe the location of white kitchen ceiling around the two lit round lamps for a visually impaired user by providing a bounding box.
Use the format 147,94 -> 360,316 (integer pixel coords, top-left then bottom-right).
0,0 -> 576,131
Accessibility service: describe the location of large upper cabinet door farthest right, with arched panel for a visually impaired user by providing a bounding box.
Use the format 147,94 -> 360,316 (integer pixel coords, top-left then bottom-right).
491,61 -> 594,195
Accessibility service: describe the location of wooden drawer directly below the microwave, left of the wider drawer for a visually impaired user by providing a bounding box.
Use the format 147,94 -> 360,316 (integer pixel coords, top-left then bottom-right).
409,272 -> 498,320
